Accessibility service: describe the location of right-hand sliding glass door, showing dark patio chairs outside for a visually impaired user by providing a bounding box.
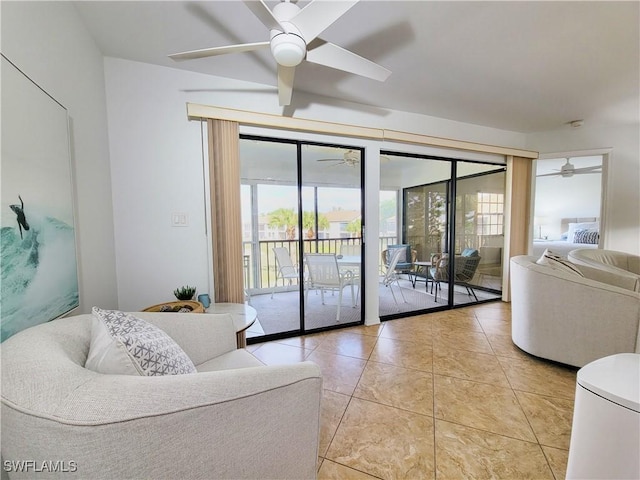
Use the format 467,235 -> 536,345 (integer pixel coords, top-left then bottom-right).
380,152 -> 505,319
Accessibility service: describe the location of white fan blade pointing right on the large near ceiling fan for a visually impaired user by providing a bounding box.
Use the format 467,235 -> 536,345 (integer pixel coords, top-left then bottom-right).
307,40 -> 391,82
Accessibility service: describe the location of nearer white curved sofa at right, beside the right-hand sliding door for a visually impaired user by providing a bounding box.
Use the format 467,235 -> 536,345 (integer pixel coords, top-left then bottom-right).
510,255 -> 640,367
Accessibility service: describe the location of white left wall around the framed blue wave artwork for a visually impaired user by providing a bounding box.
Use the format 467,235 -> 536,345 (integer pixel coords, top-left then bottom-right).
0,2 -> 118,312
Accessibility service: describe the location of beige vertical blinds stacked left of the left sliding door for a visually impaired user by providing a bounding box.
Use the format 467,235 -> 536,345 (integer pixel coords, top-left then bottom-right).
207,119 -> 244,303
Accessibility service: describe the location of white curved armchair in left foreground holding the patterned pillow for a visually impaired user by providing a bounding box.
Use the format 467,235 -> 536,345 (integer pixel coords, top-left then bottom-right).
1,313 -> 322,479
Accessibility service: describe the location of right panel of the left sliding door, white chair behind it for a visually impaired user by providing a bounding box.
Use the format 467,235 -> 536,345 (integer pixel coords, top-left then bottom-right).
301,145 -> 363,330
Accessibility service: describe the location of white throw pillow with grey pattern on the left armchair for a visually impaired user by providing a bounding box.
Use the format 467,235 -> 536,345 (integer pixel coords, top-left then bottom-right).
85,307 -> 197,376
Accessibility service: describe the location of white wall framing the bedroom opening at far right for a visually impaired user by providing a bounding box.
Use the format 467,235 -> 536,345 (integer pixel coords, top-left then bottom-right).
527,124 -> 640,254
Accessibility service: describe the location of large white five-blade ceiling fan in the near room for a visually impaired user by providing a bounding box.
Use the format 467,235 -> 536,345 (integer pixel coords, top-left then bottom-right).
169,0 -> 391,105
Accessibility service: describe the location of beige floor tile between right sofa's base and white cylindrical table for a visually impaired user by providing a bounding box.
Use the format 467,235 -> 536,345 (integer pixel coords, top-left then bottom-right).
498,355 -> 577,399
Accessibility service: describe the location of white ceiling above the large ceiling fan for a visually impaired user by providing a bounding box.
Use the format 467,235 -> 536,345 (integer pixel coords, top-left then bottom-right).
75,0 -> 640,133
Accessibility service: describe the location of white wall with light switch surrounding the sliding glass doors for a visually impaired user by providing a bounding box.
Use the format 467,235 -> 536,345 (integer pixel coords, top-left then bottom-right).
105,58 -> 525,313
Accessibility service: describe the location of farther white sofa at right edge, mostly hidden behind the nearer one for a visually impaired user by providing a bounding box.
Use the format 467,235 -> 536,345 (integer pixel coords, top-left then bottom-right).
567,248 -> 640,292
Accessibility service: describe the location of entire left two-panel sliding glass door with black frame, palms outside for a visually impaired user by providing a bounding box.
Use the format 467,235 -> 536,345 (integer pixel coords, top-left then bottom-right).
240,136 -> 363,341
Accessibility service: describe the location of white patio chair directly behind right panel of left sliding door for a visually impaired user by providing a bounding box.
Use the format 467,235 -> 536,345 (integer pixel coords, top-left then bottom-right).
304,253 -> 356,322
